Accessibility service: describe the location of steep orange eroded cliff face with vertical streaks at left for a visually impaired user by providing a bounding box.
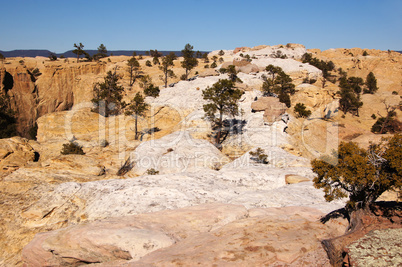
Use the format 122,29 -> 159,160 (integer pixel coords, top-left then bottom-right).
0,58 -> 106,137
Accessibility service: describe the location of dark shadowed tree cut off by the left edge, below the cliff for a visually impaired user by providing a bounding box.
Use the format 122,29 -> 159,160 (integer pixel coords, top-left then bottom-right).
0,94 -> 17,139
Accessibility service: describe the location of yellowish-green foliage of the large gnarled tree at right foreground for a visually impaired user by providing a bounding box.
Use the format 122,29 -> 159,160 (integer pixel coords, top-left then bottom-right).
311,134 -> 402,210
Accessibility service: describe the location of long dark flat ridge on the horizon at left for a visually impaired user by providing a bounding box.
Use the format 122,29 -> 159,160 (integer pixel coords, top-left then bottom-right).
0,49 -> 211,57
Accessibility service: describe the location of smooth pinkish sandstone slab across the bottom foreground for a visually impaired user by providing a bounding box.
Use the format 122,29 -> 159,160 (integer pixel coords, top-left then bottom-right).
23,204 -> 345,266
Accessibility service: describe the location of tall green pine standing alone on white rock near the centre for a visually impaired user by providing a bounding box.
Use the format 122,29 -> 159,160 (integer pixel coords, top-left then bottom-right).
202,79 -> 243,145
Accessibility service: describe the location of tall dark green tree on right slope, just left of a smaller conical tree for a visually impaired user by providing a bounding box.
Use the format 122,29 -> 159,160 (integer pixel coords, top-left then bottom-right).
338,76 -> 363,116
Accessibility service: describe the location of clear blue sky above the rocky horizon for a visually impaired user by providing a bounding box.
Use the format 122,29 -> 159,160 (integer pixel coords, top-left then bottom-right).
0,0 -> 402,53
